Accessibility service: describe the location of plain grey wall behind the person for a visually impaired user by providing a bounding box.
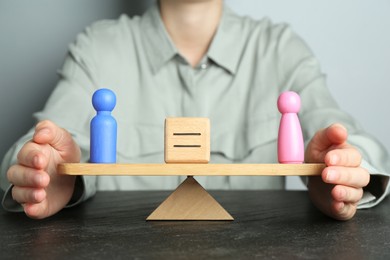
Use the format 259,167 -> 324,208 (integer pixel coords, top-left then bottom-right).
0,0 -> 390,189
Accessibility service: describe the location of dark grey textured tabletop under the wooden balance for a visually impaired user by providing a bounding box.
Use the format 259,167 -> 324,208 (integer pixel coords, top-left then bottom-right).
0,191 -> 390,260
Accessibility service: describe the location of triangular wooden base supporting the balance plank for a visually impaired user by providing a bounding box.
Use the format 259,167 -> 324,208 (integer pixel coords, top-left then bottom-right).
146,176 -> 234,220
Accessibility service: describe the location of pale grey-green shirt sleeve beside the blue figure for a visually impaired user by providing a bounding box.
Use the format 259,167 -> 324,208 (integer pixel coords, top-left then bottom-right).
0,23 -> 103,211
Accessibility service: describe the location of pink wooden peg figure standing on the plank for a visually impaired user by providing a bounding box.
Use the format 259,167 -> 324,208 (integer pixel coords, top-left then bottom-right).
278,91 -> 304,163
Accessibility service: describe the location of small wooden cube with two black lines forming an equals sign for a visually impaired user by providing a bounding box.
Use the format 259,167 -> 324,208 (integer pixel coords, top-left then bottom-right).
165,117 -> 210,163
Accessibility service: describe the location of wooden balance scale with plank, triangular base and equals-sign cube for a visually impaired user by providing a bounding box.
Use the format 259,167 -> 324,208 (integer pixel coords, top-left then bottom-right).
58,118 -> 325,220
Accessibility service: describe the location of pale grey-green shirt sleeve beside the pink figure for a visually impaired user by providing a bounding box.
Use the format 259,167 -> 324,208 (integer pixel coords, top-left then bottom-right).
277,24 -> 390,208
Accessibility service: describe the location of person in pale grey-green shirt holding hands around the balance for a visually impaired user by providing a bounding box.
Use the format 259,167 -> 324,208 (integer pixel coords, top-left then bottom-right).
2,0 -> 389,220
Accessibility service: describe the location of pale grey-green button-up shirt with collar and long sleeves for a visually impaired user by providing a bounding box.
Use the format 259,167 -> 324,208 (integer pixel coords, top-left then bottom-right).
1,1 -> 390,209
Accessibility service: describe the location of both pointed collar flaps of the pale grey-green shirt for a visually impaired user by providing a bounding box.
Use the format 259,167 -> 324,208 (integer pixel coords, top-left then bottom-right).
140,1 -> 243,74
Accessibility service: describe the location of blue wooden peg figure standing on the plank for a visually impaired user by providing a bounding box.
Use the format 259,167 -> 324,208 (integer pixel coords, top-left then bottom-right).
90,88 -> 117,163
